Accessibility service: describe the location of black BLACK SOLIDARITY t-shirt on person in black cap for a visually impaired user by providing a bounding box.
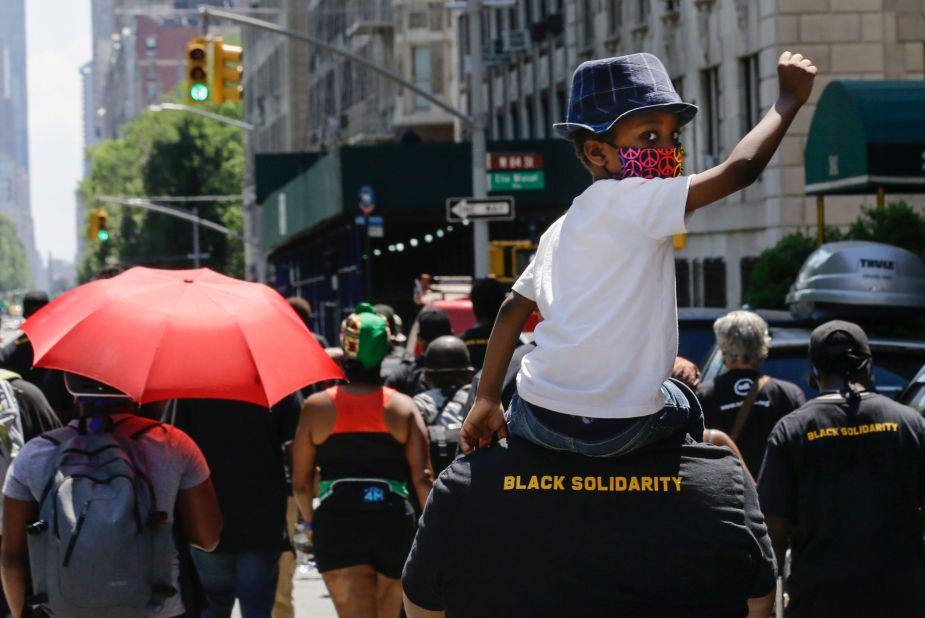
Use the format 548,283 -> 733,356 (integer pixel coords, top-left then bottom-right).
758,393 -> 925,618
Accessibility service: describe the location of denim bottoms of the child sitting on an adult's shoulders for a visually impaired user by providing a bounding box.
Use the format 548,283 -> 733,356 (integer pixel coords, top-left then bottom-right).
505,379 -> 703,457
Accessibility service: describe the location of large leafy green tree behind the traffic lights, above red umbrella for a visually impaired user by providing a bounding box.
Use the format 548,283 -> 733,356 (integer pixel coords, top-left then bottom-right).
80,97 -> 244,281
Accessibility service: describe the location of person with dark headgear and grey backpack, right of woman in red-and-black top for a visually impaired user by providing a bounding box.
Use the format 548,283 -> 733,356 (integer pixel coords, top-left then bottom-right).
414,335 -> 473,474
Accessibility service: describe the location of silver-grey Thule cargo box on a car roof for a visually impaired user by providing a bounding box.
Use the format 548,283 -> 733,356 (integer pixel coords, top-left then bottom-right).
787,241 -> 925,320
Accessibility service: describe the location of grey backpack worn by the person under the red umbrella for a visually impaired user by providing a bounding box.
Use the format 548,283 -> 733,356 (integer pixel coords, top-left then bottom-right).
27,416 -> 177,618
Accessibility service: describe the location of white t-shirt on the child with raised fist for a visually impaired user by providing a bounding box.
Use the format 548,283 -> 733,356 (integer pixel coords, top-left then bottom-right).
513,176 -> 692,418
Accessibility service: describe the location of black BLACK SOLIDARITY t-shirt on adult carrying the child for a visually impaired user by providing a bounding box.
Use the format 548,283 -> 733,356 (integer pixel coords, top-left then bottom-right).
402,437 -> 775,618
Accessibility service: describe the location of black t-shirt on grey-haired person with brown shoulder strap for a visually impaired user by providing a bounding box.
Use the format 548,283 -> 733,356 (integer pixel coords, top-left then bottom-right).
697,369 -> 806,474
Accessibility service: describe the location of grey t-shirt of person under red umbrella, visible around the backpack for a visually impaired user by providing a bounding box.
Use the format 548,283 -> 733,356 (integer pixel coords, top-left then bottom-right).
3,414 -> 209,618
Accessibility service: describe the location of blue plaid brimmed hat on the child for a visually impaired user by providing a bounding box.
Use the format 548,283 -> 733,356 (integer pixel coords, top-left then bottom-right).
552,53 -> 697,139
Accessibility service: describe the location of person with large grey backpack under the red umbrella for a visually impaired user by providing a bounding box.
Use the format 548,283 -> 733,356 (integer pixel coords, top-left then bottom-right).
0,374 -> 222,618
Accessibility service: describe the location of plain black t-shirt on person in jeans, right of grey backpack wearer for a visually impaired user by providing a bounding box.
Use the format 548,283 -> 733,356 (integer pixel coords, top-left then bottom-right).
175,395 -> 301,552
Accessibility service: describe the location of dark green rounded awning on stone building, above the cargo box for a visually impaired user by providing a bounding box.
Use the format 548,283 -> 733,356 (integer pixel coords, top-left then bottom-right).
805,80 -> 925,195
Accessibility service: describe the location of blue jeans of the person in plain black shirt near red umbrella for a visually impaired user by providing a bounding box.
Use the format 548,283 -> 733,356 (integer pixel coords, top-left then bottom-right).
192,548 -> 280,618
